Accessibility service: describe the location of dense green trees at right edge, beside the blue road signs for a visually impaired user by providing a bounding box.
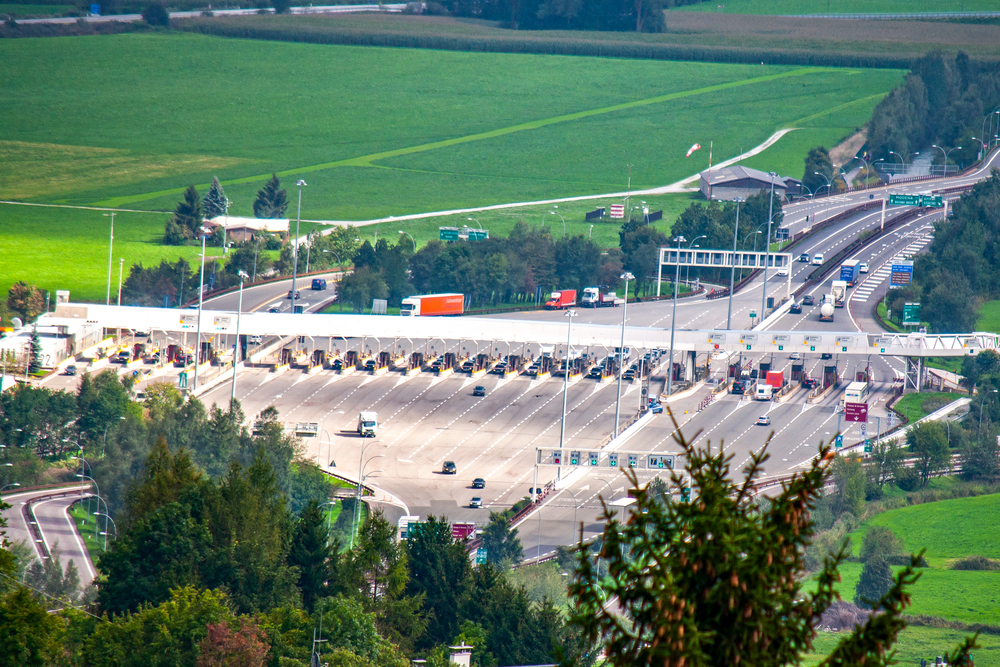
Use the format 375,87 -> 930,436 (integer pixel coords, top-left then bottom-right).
887,170 -> 1000,333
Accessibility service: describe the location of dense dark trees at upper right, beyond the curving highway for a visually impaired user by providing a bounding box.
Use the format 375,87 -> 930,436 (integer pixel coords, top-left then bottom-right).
868,53 -> 1000,172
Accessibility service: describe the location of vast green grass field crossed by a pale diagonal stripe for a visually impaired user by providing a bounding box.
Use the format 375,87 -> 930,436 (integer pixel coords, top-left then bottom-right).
0,33 -> 902,299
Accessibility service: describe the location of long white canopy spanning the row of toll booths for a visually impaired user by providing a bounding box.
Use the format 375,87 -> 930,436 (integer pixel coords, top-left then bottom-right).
50,303 -> 1000,357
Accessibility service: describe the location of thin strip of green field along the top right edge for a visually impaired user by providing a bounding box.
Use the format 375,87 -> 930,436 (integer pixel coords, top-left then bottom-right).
674,0 -> 1000,16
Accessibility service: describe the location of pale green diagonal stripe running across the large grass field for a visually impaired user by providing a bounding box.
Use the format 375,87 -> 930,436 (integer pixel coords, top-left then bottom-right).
94,67 -> 843,206
